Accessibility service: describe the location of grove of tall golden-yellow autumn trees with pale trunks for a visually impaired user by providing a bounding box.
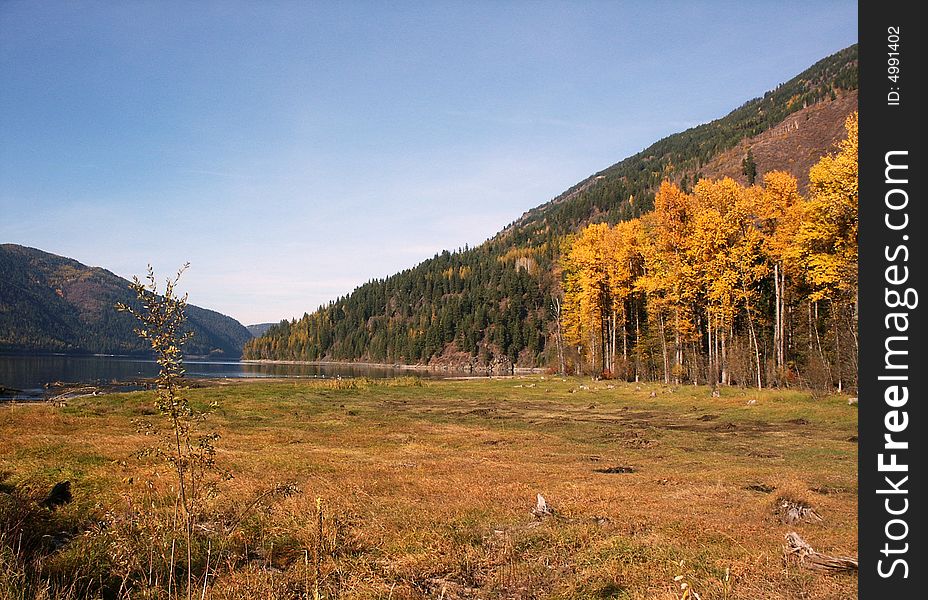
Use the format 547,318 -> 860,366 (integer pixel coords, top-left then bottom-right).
561,113 -> 858,389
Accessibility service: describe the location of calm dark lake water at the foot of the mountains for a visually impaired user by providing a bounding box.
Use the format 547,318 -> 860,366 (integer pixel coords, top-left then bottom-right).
0,354 -> 428,399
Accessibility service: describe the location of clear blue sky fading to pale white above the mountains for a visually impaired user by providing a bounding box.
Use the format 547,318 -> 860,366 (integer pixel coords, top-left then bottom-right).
0,0 -> 857,324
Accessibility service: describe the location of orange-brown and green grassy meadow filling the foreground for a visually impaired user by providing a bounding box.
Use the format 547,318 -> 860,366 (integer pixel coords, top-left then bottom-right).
0,376 -> 857,600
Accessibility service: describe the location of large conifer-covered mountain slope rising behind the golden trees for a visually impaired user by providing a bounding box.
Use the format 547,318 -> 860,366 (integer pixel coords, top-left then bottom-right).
244,45 -> 857,369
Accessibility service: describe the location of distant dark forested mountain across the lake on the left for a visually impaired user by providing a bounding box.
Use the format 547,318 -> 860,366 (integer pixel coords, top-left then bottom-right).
0,244 -> 251,357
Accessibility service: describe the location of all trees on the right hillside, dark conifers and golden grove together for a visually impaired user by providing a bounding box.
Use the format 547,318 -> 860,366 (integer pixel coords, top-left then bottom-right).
244,46 -> 857,388
